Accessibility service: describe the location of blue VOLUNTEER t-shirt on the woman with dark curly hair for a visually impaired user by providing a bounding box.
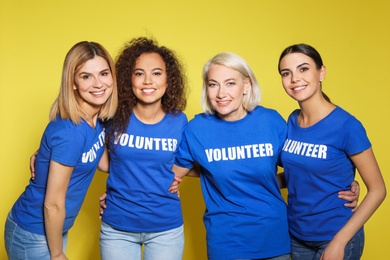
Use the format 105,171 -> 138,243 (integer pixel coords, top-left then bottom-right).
102,111 -> 187,232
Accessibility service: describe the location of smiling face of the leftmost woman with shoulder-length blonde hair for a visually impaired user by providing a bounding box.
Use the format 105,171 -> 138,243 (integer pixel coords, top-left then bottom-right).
73,56 -> 114,110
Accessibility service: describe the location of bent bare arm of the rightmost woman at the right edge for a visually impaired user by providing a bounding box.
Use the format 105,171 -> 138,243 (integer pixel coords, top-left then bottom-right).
321,148 -> 386,260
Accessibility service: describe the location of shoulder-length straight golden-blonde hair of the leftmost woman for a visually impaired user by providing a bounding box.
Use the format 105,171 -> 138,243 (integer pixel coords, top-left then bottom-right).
49,41 -> 118,124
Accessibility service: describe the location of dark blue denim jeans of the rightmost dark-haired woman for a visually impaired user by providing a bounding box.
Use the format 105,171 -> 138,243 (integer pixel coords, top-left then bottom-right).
291,232 -> 364,260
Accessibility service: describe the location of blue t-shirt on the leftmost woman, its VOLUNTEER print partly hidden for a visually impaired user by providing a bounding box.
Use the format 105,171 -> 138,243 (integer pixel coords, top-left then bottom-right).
12,117 -> 104,235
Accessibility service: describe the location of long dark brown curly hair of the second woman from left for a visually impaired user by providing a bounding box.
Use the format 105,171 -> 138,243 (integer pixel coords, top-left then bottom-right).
107,37 -> 187,142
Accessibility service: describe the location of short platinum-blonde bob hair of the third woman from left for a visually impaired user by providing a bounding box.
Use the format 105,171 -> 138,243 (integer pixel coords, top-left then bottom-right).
201,52 -> 261,114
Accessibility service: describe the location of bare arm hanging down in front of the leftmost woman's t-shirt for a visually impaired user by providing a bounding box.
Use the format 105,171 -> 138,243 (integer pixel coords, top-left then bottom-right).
44,161 -> 73,259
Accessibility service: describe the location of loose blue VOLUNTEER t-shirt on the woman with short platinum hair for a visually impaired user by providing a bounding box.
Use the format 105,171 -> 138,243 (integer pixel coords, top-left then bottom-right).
175,106 -> 290,260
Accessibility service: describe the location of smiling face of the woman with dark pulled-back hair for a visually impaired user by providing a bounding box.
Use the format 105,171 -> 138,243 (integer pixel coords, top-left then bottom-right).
279,53 -> 326,102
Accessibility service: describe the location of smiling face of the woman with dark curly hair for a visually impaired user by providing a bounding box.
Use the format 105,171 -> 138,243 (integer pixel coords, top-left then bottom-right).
131,53 -> 167,105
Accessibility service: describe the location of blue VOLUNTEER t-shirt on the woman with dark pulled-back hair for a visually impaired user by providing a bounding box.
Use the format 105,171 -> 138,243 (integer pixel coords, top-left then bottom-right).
281,107 -> 371,241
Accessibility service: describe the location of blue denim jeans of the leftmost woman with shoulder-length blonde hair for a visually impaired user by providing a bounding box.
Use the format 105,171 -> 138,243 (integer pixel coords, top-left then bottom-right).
4,213 -> 68,260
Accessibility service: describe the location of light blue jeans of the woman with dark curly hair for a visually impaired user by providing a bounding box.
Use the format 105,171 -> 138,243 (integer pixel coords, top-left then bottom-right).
100,222 -> 184,260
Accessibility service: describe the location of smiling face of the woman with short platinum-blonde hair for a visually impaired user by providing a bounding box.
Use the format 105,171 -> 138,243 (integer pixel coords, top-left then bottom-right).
207,65 -> 250,121
